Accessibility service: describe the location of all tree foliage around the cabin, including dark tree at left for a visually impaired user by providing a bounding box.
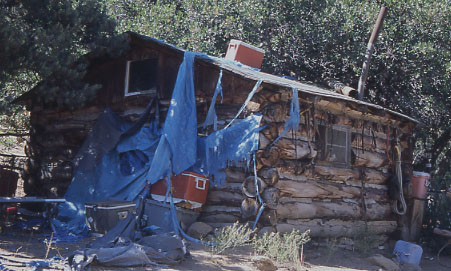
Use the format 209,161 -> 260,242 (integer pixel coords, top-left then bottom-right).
0,0 -> 451,176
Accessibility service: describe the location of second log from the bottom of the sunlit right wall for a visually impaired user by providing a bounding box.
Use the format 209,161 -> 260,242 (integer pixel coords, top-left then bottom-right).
277,201 -> 391,220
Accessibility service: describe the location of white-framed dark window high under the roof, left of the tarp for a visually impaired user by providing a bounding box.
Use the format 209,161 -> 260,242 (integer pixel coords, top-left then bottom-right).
125,58 -> 158,96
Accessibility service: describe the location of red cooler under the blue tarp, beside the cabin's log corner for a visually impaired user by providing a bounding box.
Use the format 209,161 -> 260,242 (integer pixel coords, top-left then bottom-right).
150,171 -> 209,208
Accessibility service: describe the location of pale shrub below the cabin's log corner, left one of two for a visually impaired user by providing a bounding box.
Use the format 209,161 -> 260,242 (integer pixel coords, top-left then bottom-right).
211,222 -> 254,254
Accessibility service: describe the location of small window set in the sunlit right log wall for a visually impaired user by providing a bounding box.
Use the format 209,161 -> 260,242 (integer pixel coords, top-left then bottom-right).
318,125 -> 351,166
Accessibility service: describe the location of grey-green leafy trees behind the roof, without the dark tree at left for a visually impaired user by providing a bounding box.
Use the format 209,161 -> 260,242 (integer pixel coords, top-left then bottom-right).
104,0 -> 451,176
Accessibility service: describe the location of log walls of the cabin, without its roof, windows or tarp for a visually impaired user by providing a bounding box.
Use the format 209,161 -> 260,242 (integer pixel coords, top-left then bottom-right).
23,43 -> 414,237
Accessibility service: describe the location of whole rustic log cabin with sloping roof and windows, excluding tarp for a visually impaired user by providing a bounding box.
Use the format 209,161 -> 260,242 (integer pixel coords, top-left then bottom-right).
16,33 -> 417,240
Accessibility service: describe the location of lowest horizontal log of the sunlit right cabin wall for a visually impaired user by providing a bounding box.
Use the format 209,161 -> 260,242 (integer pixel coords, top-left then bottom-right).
276,219 -> 397,238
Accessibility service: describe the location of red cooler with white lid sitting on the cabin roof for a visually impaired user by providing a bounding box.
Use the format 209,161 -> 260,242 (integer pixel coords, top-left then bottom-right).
225,39 -> 265,69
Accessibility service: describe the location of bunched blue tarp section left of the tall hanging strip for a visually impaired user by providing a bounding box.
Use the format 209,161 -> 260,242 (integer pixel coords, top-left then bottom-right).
52,110 -> 160,236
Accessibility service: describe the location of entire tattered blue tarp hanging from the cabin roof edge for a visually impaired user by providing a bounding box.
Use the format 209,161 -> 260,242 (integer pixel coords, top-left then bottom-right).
53,52 -> 261,237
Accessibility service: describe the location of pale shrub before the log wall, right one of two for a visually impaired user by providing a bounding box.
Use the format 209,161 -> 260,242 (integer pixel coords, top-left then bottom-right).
252,230 -> 310,263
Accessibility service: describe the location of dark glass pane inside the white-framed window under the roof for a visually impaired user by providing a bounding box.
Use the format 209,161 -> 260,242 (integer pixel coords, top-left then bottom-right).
128,58 -> 158,92
